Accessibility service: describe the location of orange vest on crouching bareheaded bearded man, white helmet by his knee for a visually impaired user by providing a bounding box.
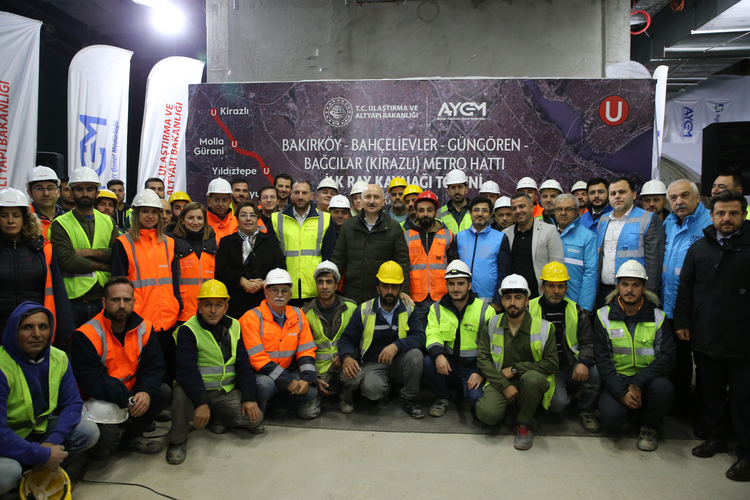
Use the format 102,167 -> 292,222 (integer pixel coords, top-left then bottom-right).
77,311 -> 152,390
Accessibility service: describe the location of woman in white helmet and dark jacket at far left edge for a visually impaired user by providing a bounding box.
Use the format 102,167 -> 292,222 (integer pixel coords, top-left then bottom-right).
0,188 -> 75,348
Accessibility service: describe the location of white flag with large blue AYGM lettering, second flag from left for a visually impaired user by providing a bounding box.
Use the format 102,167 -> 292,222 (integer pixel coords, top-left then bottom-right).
68,45 -> 133,184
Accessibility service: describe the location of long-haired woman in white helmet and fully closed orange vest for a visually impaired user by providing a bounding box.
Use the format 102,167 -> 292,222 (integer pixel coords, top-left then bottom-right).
112,189 -> 182,387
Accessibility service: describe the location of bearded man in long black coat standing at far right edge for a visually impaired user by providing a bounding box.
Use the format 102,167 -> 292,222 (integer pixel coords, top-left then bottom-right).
674,191 -> 750,481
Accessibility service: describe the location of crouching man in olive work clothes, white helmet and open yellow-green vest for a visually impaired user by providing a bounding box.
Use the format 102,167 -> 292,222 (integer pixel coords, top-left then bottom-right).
476,274 -> 557,450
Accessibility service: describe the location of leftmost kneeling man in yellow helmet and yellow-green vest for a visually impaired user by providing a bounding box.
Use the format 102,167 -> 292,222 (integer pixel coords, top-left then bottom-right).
167,280 -> 264,465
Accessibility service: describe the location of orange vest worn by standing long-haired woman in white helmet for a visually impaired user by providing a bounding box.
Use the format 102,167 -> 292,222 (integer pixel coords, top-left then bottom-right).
117,229 -> 180,331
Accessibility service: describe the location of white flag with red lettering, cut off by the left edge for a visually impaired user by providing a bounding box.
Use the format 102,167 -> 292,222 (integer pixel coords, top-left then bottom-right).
0,12 -> 42,192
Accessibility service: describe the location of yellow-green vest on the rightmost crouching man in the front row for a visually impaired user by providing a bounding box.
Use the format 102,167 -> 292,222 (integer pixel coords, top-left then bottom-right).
597,306 -> 665,377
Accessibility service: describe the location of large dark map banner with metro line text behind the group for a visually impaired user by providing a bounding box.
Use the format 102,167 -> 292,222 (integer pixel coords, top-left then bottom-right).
186,79 -> 656,200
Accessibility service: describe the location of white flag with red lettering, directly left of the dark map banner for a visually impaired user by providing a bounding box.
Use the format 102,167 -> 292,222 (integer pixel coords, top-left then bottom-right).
138,57 -> 204,197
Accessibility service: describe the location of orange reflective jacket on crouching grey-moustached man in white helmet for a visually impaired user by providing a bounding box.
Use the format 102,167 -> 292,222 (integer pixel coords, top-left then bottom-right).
240,300 -> 315,374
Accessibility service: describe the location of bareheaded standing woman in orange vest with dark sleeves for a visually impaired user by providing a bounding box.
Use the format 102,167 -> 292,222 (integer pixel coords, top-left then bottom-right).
172,201 -> 217,324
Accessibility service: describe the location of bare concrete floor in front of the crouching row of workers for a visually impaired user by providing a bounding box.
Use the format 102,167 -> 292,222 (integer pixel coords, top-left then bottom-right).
73,426 -> 750,500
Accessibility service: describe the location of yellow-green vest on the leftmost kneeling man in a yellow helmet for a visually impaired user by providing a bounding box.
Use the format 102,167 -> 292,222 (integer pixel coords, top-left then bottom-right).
174,315 -> 242,392
